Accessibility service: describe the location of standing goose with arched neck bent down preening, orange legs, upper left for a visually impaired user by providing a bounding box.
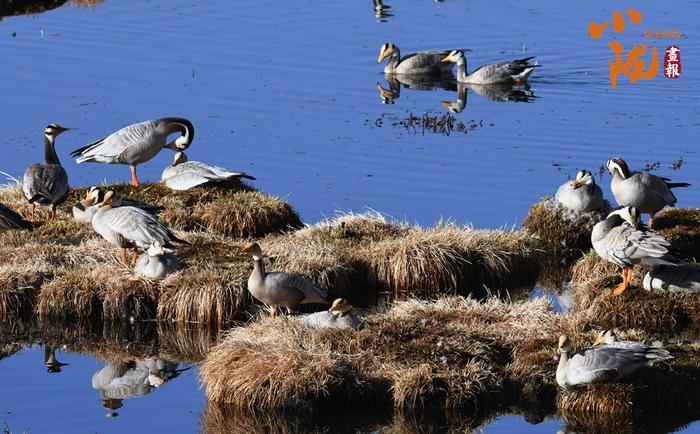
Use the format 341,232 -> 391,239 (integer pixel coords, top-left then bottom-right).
71,117 -> 194,185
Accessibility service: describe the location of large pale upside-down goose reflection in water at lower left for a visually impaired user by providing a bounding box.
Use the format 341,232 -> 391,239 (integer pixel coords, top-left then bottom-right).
92,358 -> 190,417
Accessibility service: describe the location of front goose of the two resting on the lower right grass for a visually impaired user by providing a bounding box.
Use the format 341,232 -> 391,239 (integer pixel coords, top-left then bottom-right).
556,335 -> 673,388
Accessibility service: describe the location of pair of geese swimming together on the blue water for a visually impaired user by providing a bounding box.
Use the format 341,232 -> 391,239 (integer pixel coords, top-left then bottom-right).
377,43 -> 541,84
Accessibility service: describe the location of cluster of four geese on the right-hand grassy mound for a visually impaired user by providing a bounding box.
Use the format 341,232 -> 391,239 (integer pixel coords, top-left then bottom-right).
555,157 -> 700,295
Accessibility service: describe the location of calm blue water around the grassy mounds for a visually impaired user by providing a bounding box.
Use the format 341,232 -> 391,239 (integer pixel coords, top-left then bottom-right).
0,0 -> 700,432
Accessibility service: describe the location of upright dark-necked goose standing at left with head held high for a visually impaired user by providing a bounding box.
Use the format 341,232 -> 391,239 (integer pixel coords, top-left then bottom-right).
22,124 -> 70,221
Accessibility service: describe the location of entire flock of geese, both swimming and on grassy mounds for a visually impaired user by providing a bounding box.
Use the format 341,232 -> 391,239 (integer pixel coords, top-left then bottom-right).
0,43 -> 700,387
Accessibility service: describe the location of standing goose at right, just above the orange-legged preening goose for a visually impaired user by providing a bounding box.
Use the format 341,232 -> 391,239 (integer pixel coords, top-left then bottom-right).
607,157 -> 690,227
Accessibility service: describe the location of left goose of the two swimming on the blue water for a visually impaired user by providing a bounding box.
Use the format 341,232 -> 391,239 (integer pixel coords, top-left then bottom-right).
377,43 -> 452,76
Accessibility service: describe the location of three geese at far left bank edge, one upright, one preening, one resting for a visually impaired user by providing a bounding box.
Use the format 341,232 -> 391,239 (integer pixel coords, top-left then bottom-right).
15,117 -> 255,221
